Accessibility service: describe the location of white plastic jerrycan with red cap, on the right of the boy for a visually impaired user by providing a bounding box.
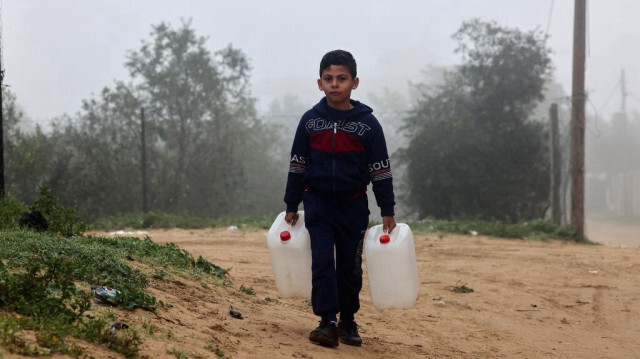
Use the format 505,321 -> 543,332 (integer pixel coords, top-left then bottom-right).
364,223 -> 418,310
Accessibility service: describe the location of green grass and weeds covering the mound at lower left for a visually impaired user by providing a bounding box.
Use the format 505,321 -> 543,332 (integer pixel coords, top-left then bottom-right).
0,229 -> 227,358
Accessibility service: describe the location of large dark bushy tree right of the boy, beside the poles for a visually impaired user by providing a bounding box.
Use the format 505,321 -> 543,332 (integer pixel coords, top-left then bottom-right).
401,19 -> 551,220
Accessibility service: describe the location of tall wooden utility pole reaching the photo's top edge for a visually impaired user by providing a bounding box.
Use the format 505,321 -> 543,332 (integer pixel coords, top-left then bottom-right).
571,0 -> 587,241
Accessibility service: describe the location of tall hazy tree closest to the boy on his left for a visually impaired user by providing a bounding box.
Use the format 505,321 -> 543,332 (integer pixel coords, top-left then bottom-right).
126,23 -> 284,216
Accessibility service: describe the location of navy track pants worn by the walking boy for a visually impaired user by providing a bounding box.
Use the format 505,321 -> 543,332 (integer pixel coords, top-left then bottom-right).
304,191 -> 369,320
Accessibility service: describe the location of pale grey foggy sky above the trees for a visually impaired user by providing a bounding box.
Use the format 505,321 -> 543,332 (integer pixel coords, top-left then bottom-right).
0,0 -> 640,124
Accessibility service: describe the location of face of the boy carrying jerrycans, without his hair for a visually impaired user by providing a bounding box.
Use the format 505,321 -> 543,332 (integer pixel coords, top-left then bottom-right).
318,65 -> 360,110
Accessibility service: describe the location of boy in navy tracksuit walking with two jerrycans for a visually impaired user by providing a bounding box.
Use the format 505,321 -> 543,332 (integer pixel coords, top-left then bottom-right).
284,50 -> 396,347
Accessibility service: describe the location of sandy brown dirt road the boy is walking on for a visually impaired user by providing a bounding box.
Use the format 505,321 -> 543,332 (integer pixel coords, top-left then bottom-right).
56,219 -> 640,359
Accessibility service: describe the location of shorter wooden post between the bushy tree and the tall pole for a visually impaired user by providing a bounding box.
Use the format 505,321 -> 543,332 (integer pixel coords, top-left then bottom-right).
549,103 -> 562,226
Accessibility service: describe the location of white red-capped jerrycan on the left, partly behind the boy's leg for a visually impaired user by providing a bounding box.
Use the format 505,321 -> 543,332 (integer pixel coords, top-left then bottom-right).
267,211 -> 311,299
